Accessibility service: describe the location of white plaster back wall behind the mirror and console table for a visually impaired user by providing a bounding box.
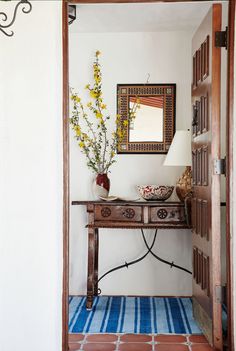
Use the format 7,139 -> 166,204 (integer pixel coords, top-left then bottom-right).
70,32 -> 192,295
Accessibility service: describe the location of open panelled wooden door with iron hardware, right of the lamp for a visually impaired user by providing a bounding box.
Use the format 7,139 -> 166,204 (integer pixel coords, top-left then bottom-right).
192,4 -> 222,350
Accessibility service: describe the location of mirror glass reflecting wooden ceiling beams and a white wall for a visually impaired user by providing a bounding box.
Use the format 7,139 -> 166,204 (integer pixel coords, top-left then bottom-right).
129,96 -> 164,142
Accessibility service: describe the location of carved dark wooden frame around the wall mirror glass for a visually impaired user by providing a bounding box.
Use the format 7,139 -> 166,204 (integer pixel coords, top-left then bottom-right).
117,84 -> 176,154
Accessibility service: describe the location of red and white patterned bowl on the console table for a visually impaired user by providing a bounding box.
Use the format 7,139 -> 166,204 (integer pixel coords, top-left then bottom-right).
137,185 -> 174,201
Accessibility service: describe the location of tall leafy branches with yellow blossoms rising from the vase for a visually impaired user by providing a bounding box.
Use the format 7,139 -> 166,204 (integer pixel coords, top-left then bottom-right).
70,50 -> 142,172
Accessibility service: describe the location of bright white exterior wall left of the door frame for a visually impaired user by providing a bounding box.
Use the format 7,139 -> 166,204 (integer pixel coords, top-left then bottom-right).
0,1 -> 62,351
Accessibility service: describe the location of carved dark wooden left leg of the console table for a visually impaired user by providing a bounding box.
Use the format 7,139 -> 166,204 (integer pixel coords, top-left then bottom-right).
86,228 -> 95,309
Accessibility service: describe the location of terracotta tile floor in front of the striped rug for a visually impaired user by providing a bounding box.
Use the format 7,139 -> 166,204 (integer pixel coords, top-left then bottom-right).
69,334 -> 213,351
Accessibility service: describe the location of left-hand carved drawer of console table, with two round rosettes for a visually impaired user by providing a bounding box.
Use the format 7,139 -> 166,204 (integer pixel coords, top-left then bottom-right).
95,205 -> 142,222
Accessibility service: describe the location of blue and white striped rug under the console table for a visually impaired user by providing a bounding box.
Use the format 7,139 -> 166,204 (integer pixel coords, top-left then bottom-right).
69,296 -> 201,334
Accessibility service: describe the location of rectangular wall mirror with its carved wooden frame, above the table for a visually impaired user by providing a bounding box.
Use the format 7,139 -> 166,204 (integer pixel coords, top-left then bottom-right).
117,84 -> 176,154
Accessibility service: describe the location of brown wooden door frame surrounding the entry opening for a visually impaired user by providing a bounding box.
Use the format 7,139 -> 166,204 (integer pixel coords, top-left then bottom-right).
62,0 -> 236,351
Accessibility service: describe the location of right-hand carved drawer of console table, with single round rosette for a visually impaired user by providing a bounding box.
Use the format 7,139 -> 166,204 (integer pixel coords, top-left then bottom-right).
149,206 -> 186,223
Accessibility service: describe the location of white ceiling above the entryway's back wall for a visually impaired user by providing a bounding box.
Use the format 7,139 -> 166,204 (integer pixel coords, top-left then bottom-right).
70,1 -> 226,33
